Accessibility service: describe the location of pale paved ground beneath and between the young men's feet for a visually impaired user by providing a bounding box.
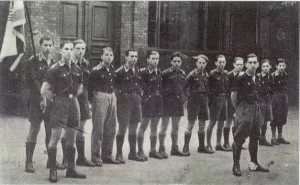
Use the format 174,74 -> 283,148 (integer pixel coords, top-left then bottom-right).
0,108 -> 299,185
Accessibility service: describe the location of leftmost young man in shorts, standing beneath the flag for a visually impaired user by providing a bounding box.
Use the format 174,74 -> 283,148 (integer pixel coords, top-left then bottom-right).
25,35 -> 64,173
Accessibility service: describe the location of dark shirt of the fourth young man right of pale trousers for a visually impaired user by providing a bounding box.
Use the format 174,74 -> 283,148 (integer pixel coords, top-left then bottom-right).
185,69 -> 208,93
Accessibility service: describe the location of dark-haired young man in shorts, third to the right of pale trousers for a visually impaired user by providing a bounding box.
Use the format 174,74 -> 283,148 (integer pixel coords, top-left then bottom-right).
159,52 -> 188,158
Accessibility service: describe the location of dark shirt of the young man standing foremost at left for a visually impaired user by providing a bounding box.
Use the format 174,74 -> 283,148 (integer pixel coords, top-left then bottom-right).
44,61 -> 83,96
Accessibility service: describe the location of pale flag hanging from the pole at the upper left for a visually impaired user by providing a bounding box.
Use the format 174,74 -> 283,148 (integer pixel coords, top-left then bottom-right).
0,1 -> 26,71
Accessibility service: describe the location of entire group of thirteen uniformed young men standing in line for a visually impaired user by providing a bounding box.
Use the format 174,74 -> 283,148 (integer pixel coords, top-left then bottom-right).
25,36 -> 289,182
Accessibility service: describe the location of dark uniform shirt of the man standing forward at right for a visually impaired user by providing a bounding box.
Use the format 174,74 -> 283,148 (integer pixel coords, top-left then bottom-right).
232,72 -> 259,105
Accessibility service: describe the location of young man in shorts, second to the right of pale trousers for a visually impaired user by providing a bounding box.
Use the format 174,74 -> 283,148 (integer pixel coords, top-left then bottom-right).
138,51 -> 163,161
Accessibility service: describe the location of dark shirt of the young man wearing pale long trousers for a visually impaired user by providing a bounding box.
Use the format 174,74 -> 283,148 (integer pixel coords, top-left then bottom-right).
88,65 -> 116,100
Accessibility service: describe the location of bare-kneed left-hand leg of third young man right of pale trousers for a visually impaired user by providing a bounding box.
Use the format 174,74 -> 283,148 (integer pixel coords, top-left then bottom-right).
158,116 -> 170,159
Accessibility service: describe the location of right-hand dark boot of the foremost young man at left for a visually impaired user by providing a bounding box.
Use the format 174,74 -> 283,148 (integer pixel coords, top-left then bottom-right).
66,146 -> 86,179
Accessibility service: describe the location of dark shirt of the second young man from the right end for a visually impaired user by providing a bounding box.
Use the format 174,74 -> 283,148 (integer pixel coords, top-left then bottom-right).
257,73 -> 272,98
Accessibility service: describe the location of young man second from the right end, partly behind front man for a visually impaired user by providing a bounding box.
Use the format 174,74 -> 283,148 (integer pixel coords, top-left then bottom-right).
257,59 -> 273,146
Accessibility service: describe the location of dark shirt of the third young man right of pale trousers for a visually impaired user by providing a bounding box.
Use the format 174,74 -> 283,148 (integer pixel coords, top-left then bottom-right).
162,68 -> 186,99
